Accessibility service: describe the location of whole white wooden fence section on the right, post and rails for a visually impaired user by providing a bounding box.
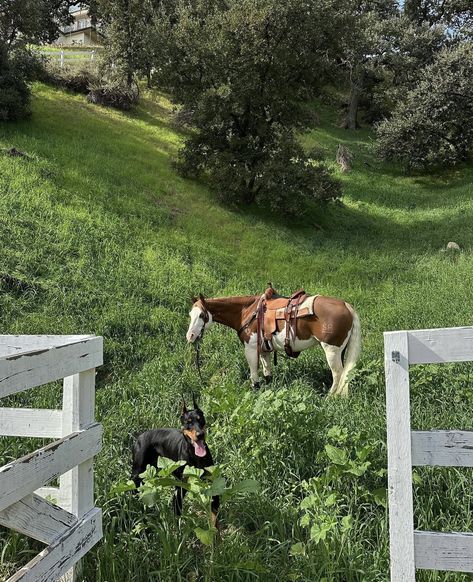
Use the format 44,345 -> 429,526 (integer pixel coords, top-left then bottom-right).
384,327 -> 473,582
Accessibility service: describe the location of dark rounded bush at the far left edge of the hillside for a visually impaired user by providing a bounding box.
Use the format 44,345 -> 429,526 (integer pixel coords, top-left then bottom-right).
0,47 -> 31,121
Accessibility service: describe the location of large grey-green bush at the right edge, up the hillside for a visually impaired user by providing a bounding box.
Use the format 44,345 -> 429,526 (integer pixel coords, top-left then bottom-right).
377,43 -> 473,170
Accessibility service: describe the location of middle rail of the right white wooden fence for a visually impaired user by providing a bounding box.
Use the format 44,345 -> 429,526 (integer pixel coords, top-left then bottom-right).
411,430 -> 473,467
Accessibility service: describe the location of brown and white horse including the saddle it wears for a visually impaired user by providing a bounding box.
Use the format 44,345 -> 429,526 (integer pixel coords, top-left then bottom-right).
186,285 -> 361,395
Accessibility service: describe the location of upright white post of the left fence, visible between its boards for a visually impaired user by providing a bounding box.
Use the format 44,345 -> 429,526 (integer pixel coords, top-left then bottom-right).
59,368 -> 95,582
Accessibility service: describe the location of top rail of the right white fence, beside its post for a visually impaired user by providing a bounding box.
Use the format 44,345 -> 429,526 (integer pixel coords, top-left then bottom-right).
407,327 -> 473,364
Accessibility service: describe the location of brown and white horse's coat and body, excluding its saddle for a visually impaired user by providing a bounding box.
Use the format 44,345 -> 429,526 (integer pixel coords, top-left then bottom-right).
186,295 -> 361,395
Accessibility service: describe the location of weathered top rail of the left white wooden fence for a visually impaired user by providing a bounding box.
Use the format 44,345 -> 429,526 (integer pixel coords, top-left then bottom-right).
0,336 -> 103,398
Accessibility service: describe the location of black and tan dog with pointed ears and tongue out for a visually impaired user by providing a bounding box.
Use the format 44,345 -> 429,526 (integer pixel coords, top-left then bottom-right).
131,395 -> 220,526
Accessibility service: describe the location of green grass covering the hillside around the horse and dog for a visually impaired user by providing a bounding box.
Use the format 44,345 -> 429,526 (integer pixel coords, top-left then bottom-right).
0,85 -> 473,582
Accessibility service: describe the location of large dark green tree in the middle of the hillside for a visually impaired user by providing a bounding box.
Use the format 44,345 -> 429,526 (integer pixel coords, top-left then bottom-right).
156,0 -> 347,212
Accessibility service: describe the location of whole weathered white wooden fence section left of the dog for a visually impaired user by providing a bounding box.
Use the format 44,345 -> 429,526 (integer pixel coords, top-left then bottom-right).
0,335 -> 103,582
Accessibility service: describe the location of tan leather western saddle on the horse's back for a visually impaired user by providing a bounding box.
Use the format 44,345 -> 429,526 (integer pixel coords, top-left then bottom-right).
242,283 -> 313,358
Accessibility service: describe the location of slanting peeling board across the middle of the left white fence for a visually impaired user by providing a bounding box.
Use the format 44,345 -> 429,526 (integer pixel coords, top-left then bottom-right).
0,423 -> 102,511
